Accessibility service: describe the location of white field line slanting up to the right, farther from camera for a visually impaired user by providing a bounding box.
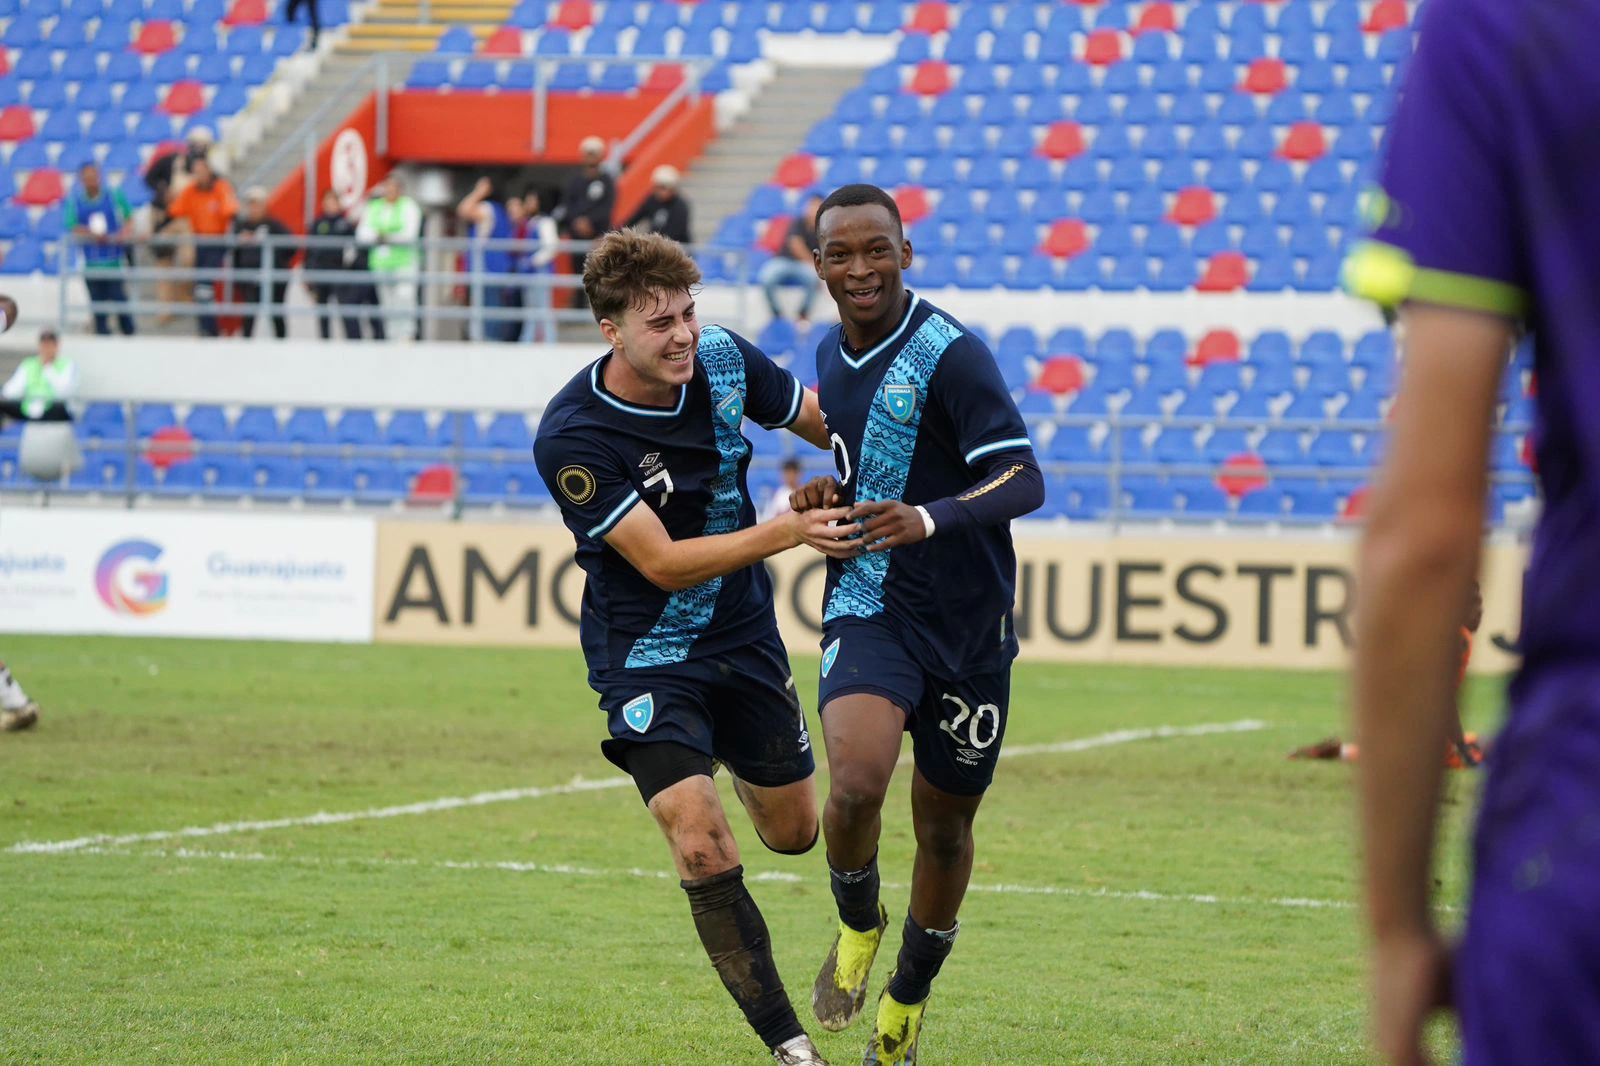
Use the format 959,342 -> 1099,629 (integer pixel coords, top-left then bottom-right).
6,719 -> 1266,855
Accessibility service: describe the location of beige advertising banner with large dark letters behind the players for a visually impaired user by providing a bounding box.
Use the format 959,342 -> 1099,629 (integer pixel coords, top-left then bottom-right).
373,522 -> 1525,672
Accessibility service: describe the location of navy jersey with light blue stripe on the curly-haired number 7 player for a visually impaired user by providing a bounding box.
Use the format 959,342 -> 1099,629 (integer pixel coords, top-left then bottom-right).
533,327 -> 802,671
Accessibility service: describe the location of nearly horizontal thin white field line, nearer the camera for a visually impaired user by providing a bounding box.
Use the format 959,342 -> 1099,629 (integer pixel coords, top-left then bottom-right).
59,847 -> 1355,911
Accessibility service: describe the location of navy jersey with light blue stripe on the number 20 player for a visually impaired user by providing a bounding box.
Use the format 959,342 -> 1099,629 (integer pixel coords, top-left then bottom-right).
816,293 -> 1032,677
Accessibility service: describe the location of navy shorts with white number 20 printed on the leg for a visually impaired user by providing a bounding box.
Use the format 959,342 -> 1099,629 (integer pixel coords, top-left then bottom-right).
818,618 -> 1011,795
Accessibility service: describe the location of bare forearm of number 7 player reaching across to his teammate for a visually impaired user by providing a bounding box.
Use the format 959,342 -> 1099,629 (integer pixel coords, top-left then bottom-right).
605,492 -> 854,592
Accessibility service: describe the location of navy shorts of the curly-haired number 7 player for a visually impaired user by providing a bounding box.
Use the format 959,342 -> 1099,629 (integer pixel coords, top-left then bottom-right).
589,631 -> 816,787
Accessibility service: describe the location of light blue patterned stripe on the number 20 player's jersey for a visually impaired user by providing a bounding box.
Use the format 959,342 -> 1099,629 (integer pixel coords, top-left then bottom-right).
822,315 -> 962,621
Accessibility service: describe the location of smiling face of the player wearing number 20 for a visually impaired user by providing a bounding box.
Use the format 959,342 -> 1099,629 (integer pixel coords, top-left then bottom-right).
816,203 -> 910,347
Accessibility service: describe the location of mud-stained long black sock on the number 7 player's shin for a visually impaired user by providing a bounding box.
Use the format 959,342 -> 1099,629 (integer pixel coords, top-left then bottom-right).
678,866 -> 805,1047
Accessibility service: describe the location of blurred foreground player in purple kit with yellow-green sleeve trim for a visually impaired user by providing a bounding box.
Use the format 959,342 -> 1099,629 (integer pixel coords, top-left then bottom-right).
1347,0 -> 1600,1066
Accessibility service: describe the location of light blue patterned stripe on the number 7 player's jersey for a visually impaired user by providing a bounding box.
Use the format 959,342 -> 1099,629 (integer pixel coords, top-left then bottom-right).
626,327 -> 750,667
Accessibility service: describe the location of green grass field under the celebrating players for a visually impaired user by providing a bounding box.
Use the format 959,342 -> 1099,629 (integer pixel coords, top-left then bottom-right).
0,637 -> 1499,1066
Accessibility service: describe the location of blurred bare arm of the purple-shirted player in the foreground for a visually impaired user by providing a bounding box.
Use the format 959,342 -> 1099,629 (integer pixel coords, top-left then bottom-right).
1352,306 -> 1510,1061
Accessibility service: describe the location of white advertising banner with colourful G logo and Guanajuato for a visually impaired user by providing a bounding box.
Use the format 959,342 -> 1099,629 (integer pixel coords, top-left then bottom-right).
0,507 -> 376,642
